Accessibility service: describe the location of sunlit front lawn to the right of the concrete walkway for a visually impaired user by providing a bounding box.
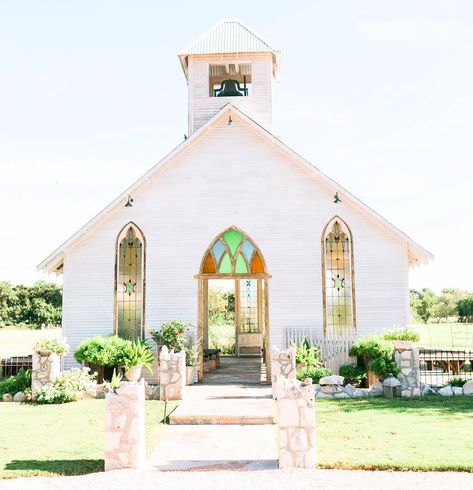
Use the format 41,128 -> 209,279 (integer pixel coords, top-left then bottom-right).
317,397 -> 473,472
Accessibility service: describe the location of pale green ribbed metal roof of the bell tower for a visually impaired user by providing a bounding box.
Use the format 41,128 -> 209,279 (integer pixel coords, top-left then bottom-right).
179,19 -> 280,78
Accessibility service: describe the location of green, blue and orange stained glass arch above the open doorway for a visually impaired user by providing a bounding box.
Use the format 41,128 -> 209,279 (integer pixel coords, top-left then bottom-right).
201,228 -> 266,274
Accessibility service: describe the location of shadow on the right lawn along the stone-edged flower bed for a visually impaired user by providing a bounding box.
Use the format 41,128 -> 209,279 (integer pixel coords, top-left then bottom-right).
319,396 -> 473,415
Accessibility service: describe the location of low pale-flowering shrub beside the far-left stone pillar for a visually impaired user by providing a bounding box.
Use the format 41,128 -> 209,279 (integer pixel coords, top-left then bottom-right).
35,368 -> 94,404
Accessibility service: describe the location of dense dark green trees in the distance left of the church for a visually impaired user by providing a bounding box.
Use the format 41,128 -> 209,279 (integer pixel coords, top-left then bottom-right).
0,281 -> 62,328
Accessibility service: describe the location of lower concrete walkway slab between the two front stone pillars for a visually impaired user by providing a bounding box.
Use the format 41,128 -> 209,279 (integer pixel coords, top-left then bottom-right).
148,425 -> 278,471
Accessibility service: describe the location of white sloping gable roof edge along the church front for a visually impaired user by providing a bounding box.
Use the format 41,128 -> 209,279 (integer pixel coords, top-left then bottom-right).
37,103 -> 433,274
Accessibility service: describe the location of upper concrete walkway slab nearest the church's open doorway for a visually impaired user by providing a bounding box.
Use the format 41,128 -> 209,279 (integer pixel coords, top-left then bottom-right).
169,384 -> 274,425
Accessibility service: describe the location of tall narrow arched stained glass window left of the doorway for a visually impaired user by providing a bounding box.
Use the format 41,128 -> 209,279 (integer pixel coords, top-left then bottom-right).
115,224 -> 145,339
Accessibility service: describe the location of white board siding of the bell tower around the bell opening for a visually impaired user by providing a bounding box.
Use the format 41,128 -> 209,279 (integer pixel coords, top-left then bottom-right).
187,53 -> 272,134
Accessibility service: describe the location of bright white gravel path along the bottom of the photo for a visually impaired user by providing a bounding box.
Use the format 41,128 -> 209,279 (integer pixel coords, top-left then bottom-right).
0,470 -> 473,490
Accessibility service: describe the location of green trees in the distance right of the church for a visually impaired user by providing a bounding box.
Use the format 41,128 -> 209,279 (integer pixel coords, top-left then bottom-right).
410,288 -> 473,323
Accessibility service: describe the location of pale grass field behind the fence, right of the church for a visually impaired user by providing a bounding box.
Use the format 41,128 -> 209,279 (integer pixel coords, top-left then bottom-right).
410,323 -> 473,349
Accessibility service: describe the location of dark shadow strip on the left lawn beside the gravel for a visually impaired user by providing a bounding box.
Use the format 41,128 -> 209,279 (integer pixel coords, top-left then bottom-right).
5,459 -> 104,476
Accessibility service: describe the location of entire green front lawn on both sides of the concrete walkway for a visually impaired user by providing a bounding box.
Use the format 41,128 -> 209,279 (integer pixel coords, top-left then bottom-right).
0,397 -> 473,478
